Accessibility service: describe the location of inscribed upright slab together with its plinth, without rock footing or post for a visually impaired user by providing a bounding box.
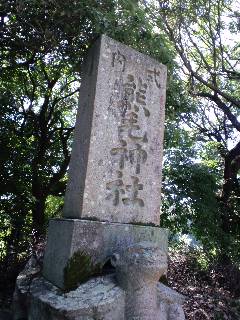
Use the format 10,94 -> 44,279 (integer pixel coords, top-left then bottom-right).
43,36 -> 167,288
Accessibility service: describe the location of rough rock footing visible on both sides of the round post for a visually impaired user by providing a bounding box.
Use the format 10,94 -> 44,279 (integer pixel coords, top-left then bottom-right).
13,255 -> 185,320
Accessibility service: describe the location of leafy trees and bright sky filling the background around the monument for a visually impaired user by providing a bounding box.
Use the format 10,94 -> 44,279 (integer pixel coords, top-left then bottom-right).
0,0 -> 240,319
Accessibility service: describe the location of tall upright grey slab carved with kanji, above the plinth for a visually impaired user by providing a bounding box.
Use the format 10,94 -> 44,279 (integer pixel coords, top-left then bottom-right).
63,36 -> 167,225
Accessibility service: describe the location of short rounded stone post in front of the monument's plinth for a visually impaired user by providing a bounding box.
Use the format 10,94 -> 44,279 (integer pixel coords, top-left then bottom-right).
112,241 -> 167,320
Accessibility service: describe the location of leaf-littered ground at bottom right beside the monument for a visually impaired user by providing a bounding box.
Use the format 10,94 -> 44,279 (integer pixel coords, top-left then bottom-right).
168,252 -> 240,320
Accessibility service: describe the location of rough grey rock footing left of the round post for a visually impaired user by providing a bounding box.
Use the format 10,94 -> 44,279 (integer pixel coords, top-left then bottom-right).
13,268 -> 125,320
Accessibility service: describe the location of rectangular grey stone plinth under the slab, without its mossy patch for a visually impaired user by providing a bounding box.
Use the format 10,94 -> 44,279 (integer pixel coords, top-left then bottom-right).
43,219 -> 168,289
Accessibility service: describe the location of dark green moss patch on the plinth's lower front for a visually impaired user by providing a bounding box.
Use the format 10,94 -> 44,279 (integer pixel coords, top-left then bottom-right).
64,251 -> 102,292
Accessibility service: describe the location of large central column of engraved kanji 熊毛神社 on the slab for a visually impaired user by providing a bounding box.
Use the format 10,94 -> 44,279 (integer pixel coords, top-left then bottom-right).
106,68 -> 151,207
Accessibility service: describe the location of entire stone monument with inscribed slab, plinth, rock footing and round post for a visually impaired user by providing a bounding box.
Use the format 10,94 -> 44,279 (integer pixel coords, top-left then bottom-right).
15,36 -> 184,320
